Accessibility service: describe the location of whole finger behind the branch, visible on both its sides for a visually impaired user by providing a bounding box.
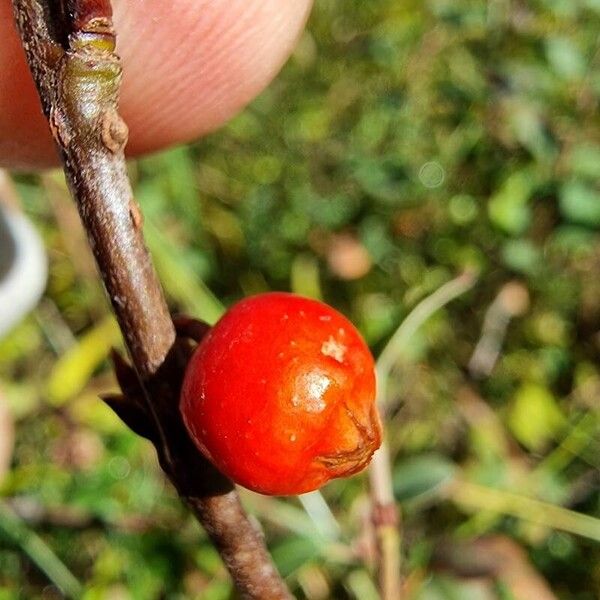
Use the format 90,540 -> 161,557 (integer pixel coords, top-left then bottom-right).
0,0 -> 311,169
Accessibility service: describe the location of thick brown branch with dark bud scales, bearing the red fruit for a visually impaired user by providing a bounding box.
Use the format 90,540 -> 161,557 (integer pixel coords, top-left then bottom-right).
13,0 -> 291,599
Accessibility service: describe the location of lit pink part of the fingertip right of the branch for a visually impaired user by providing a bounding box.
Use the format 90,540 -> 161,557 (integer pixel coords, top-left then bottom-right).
115,0 -> 310,154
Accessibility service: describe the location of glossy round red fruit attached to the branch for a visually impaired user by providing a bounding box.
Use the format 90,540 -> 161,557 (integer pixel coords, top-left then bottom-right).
181,293 -> 381,495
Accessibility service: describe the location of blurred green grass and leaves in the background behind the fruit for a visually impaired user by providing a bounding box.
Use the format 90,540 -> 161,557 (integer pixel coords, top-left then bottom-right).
0,0 -> 600,600
